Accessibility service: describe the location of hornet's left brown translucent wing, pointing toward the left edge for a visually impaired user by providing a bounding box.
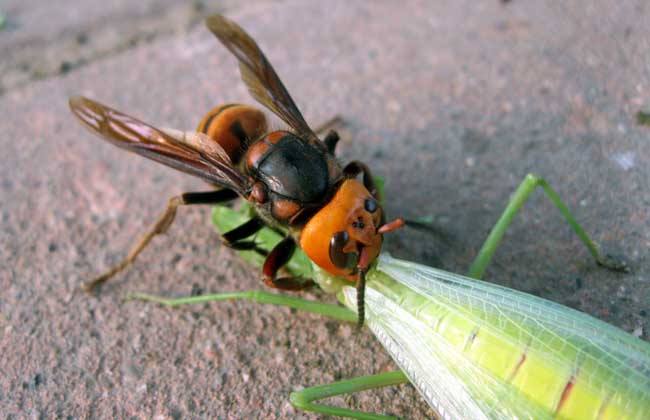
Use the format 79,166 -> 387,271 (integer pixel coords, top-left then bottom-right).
70,97 -> 249,195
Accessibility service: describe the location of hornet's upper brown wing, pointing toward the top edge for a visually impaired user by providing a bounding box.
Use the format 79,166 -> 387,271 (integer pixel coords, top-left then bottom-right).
206,15 -> 316,144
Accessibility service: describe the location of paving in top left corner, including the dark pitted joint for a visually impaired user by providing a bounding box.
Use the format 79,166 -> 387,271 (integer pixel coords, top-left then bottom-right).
0,0 -> 268,93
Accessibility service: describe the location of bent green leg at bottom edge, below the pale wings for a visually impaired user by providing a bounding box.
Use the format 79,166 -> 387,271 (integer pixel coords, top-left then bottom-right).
290,370 -> 408,420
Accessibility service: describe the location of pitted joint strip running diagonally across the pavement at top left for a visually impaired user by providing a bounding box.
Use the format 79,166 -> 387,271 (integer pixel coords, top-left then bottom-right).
0,0 -> 265,96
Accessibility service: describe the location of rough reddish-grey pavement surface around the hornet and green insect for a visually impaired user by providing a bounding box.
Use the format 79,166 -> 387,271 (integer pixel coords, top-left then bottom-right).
0,0 -> 650,418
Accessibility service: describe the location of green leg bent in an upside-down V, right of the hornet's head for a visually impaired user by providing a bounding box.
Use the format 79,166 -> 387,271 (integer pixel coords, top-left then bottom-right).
467,174 -> 629,279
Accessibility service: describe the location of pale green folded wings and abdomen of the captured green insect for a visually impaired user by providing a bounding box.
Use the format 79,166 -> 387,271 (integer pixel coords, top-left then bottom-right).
343,255 -> 650,419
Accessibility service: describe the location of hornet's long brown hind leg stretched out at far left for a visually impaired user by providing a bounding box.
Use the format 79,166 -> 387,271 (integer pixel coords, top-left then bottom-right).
82,189 -> 238,292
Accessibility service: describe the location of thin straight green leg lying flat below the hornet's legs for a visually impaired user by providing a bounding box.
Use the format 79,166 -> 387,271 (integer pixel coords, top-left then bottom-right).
127,290 -> 357,322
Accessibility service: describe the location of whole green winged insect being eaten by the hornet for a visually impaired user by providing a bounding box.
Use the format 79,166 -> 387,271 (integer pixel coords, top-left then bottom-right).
132,175 -> 650,419
